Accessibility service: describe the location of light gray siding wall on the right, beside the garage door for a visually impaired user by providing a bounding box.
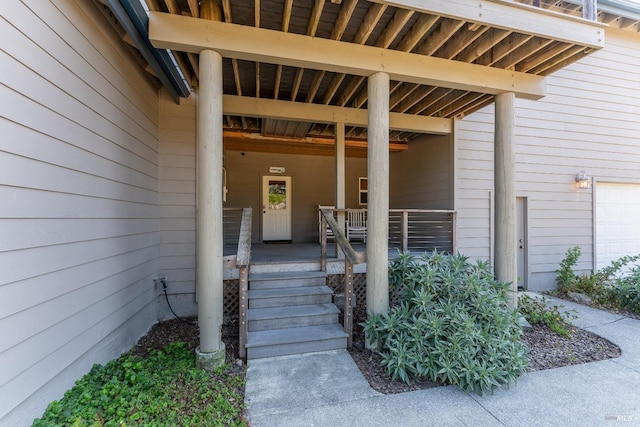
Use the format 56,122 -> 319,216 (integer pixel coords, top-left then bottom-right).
457,30 -> 640,289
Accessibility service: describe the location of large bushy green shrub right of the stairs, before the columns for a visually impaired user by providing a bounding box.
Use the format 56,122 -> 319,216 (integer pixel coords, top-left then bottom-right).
364,252 -> 528,395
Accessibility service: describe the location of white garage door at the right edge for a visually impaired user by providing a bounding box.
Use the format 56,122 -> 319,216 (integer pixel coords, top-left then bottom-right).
595,183 -> 640,268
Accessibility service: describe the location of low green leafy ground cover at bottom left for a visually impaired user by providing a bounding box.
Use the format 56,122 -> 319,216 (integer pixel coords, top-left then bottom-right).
33,343 -> 245,427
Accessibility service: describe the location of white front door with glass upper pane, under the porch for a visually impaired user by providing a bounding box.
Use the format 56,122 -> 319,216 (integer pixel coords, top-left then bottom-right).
262,176 -> 291,241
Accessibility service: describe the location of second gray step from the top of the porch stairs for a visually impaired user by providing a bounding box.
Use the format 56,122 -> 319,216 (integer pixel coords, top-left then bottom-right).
249,286 -> 333,309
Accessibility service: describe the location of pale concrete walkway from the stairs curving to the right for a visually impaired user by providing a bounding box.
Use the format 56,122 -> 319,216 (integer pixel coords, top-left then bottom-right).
245,300 -> 640,427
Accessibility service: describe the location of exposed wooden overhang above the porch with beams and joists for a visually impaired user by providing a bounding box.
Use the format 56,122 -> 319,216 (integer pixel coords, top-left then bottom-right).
112,0 -> 608,142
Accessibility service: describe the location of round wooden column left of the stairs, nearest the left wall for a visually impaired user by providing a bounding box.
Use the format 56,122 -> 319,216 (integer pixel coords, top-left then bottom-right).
196,50 -> 224,362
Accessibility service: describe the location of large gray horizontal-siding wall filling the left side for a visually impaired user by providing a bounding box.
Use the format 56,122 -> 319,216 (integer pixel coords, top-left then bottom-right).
0,0 -> 160,425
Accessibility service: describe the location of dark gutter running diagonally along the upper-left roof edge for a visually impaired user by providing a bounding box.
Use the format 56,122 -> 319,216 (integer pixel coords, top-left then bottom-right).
105,0 -> 191,103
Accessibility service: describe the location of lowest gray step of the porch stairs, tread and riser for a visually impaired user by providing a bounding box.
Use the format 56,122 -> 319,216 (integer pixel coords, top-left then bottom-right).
247,324 -> 347,359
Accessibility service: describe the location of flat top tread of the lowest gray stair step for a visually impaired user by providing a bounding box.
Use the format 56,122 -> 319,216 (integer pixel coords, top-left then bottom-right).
247,323 -> 347,348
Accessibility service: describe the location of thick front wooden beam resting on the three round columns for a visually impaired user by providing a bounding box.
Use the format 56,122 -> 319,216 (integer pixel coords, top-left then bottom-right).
149,12 -> 545,99
